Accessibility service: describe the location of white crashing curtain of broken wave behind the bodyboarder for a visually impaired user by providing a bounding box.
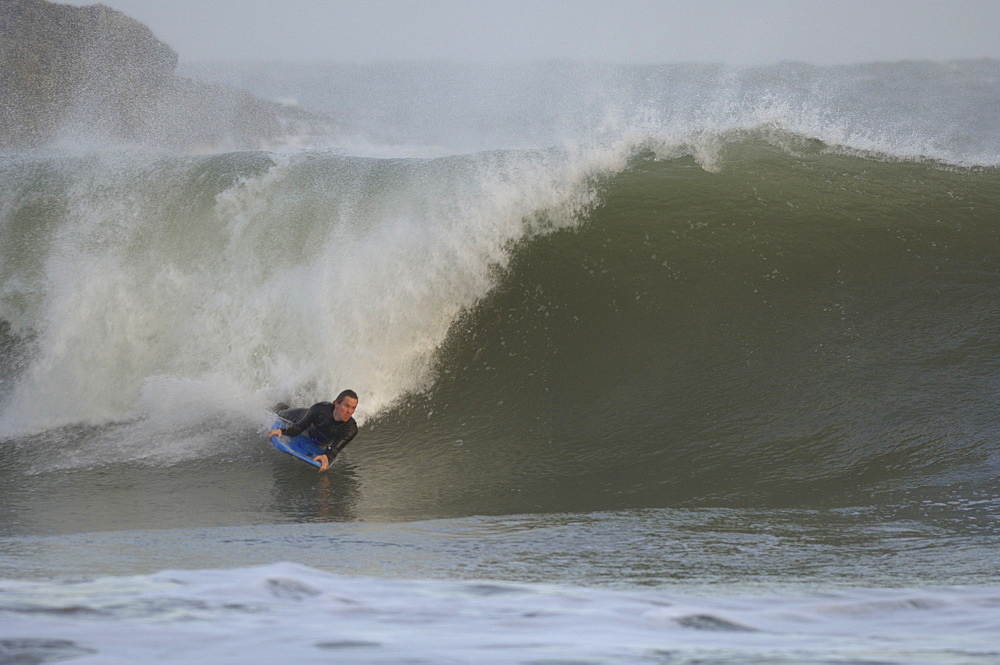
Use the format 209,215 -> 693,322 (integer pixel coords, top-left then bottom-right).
3,143 -> 625,440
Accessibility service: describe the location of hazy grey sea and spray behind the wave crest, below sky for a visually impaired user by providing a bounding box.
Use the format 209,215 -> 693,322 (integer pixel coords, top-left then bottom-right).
180,60 -> 1000,165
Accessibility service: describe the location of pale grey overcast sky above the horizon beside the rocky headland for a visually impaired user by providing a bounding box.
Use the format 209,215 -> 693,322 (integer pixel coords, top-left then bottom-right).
67,0 -> 1000,65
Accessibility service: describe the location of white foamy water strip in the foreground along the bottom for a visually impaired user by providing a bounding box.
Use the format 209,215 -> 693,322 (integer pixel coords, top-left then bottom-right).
0,563 -> 1000,665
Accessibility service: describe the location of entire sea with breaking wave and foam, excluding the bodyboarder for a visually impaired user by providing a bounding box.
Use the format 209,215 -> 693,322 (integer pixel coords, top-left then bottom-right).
0,61 -> 1000,665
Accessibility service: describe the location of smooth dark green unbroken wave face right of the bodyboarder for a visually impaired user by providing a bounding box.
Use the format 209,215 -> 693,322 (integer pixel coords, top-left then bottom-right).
373,149 -> 1000,511
